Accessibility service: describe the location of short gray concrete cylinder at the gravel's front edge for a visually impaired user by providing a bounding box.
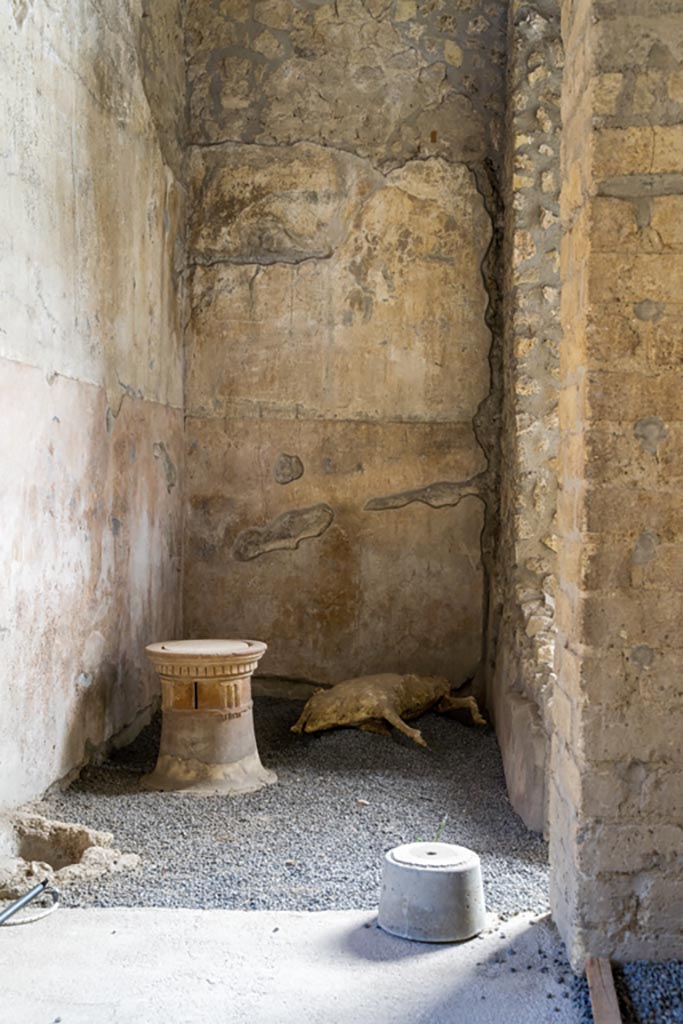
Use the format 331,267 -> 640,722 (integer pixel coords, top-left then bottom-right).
378,843 -> 485,942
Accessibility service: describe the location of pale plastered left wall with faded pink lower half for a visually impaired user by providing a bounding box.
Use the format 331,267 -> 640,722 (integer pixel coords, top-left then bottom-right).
0,0 -> 184,805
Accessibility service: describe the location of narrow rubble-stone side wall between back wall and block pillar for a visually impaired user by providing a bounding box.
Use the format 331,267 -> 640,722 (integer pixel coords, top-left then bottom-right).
489,0 -> 563,831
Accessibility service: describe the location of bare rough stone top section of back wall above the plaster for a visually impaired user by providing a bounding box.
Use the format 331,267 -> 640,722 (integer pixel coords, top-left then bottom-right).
187,0 -> 505,167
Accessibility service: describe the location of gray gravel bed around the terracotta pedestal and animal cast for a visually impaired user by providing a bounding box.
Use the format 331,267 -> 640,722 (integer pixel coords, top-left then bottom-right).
41,697 -> 548,918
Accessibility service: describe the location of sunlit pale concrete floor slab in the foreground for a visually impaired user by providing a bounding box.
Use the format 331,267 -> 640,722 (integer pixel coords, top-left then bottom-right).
0,908 -> 578,1024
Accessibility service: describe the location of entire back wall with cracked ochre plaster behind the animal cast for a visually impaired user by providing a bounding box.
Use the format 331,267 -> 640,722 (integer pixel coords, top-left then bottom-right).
184,0 -> 505,682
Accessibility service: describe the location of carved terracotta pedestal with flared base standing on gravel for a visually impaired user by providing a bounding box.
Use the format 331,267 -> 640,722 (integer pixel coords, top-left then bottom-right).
142,640 -> 276,796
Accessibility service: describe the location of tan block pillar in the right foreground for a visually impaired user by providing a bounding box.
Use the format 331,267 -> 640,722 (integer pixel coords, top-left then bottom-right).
550,0 -> 683,966
